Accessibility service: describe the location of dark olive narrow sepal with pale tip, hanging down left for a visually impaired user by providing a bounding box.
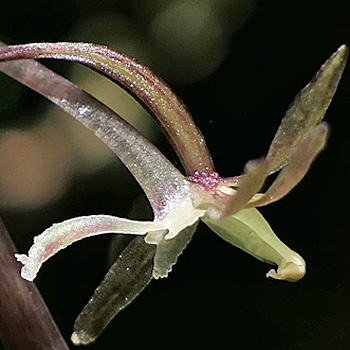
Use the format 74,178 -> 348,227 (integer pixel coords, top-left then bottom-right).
71,237 -> 155,345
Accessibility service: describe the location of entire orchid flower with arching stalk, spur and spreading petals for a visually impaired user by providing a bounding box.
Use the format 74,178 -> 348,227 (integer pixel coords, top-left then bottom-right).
0,42 -> 347,344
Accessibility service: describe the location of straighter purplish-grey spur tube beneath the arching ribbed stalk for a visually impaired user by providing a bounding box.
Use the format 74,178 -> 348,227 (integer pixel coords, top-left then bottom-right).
0,42 -> 189,218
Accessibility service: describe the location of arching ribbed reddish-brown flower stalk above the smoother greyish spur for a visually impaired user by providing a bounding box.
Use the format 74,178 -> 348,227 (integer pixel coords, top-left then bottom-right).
1,42 -> 214,174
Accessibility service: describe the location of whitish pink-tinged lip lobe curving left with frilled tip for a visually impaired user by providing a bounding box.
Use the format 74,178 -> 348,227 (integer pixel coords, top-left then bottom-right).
16,215 -> 165,281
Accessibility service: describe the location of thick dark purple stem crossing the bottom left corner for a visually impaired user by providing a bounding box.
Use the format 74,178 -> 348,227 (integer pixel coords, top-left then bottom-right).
0,219 -> 69,350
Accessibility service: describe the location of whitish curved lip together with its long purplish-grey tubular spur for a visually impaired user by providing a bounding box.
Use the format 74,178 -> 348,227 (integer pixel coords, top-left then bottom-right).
1,41 -> 204,280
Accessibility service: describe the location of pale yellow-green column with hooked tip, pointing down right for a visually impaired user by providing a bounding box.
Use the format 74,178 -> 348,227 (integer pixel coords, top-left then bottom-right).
202,209 -> 306,282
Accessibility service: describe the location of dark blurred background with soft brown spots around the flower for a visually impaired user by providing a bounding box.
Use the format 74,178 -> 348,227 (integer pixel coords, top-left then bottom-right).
0,0 -> 350,350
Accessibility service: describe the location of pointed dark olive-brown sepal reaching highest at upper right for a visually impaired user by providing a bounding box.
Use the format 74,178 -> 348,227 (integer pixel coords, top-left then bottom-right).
266,45 -> 348,173
